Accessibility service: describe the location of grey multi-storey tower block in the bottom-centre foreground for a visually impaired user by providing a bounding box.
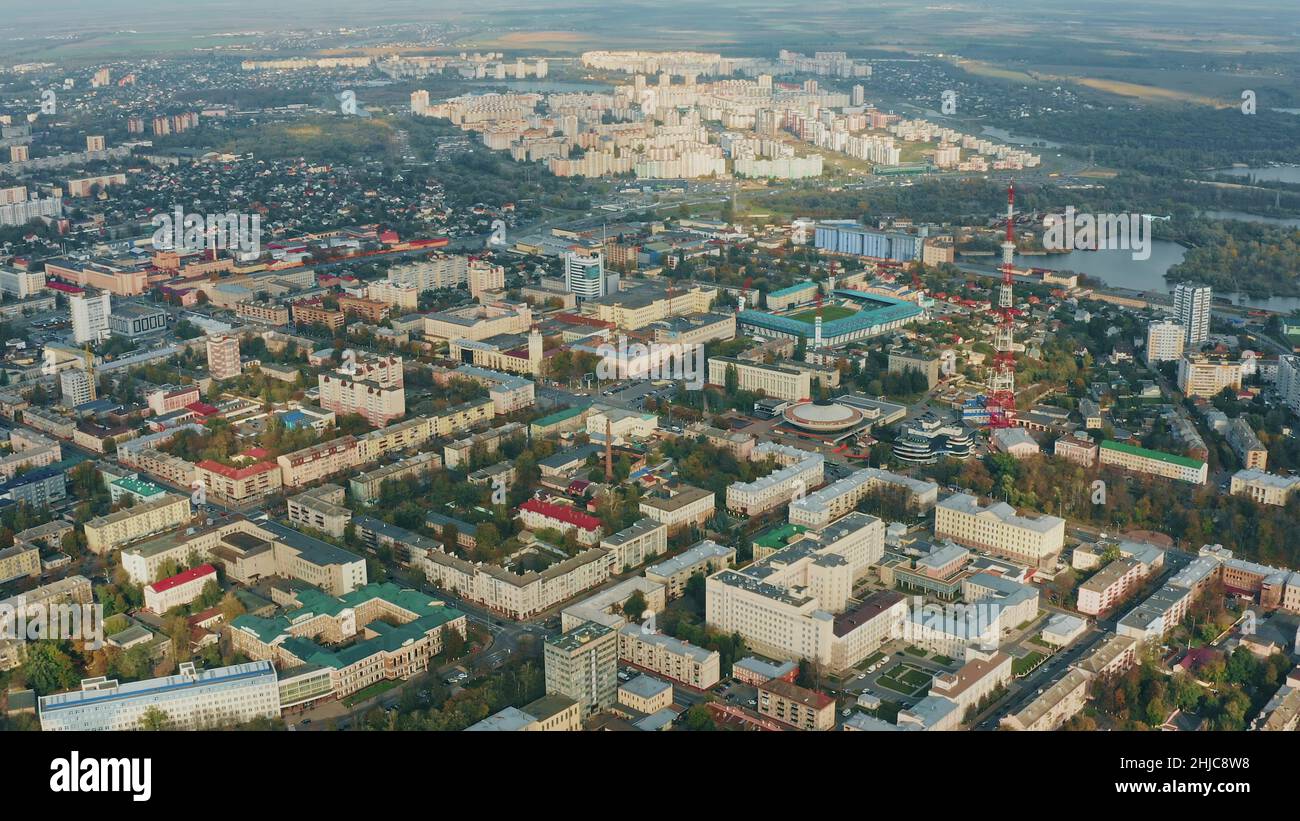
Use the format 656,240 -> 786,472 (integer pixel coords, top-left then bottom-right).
543,621 -> 619,716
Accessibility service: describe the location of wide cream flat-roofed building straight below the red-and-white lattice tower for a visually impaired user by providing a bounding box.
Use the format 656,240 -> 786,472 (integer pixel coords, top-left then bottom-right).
935,494 -> 1065,566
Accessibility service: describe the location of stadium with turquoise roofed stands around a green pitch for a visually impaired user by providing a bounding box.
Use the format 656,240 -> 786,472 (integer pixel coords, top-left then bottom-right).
737,288 -> 924,347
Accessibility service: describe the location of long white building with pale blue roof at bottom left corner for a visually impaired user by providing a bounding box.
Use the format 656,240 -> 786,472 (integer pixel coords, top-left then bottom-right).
39,661 -> 280,731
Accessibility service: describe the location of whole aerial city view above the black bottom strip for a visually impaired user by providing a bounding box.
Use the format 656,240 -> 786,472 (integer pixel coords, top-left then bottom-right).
0,0 -> 1300,774
